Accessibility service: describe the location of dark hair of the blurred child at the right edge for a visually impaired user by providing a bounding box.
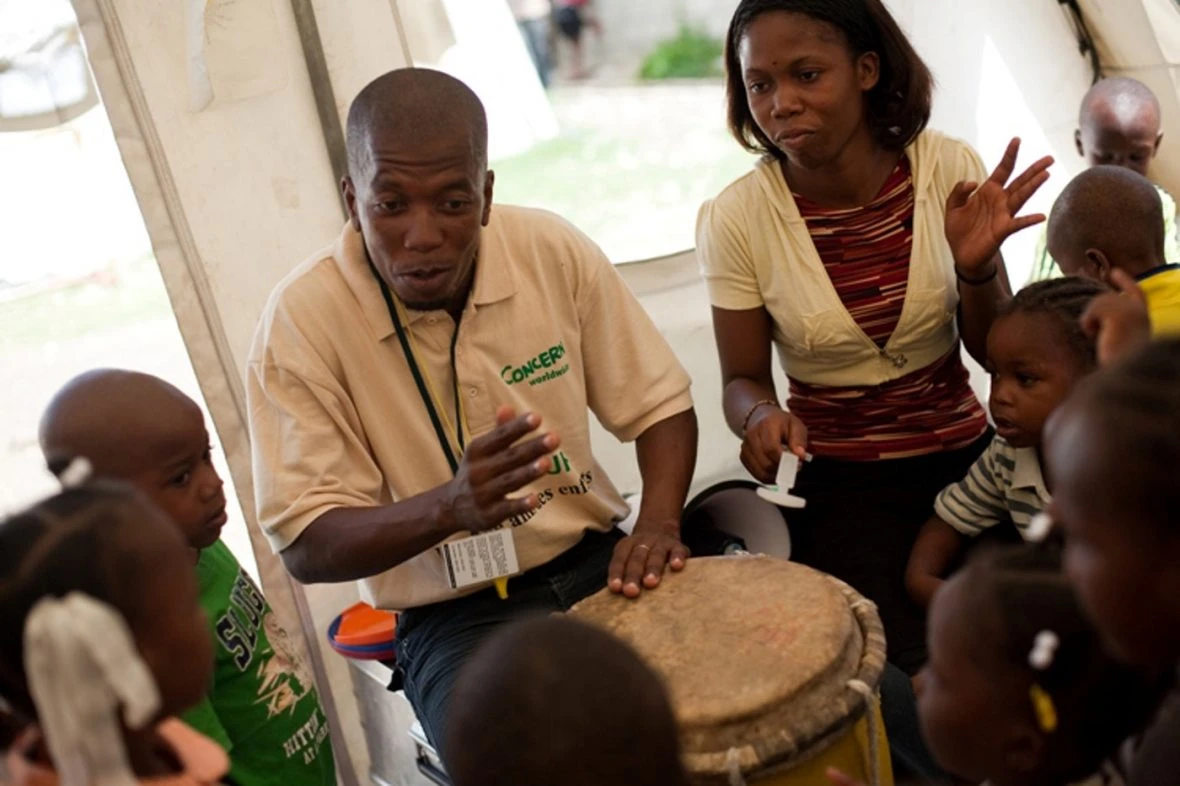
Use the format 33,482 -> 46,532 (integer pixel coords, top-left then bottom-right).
1070,339 -> 1180,537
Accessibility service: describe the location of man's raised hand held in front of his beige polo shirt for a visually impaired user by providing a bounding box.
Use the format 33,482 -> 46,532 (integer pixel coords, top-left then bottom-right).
441,407 -> 562,532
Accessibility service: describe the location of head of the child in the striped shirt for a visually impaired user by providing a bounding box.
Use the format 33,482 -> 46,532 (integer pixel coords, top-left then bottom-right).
988,279 -> 1106,447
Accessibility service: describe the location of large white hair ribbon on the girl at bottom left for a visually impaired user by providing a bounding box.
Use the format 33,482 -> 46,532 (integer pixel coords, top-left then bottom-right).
25,592 -> 160,786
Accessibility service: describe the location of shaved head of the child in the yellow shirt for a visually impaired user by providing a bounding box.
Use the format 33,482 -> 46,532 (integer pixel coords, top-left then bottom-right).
1049,166 -> 1165,281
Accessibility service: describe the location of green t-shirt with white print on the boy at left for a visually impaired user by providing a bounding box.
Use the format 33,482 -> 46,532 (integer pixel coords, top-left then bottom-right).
184,541 -> 336,786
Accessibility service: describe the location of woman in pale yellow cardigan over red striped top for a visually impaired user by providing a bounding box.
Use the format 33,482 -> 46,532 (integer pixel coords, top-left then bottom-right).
697,0 -> 1051,673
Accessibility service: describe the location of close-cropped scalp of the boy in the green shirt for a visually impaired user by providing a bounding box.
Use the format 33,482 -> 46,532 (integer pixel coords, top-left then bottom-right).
40,368 -> 204,479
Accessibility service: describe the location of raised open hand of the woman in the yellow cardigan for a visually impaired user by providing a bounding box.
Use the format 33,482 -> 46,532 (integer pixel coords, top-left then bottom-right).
945,139 -> 1053,279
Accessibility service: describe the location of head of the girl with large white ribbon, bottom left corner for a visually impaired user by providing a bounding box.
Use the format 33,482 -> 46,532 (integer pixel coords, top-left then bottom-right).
0,483 -> 212,731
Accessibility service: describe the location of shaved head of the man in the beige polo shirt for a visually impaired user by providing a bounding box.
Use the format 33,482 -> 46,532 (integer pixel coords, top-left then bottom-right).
341,68 -> 496,319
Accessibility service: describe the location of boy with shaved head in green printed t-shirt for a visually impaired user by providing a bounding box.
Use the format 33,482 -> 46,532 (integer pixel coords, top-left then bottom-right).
40,369 -> 336,786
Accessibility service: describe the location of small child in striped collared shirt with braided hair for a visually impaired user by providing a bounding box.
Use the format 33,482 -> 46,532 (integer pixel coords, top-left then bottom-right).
905,279 -> 1106,607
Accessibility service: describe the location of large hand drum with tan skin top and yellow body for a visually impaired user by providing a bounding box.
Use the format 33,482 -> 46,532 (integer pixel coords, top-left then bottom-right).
570,555 -> 892,786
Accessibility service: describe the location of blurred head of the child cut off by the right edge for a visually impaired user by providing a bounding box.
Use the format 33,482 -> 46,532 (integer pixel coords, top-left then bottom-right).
1045,339 -> 1180,666
